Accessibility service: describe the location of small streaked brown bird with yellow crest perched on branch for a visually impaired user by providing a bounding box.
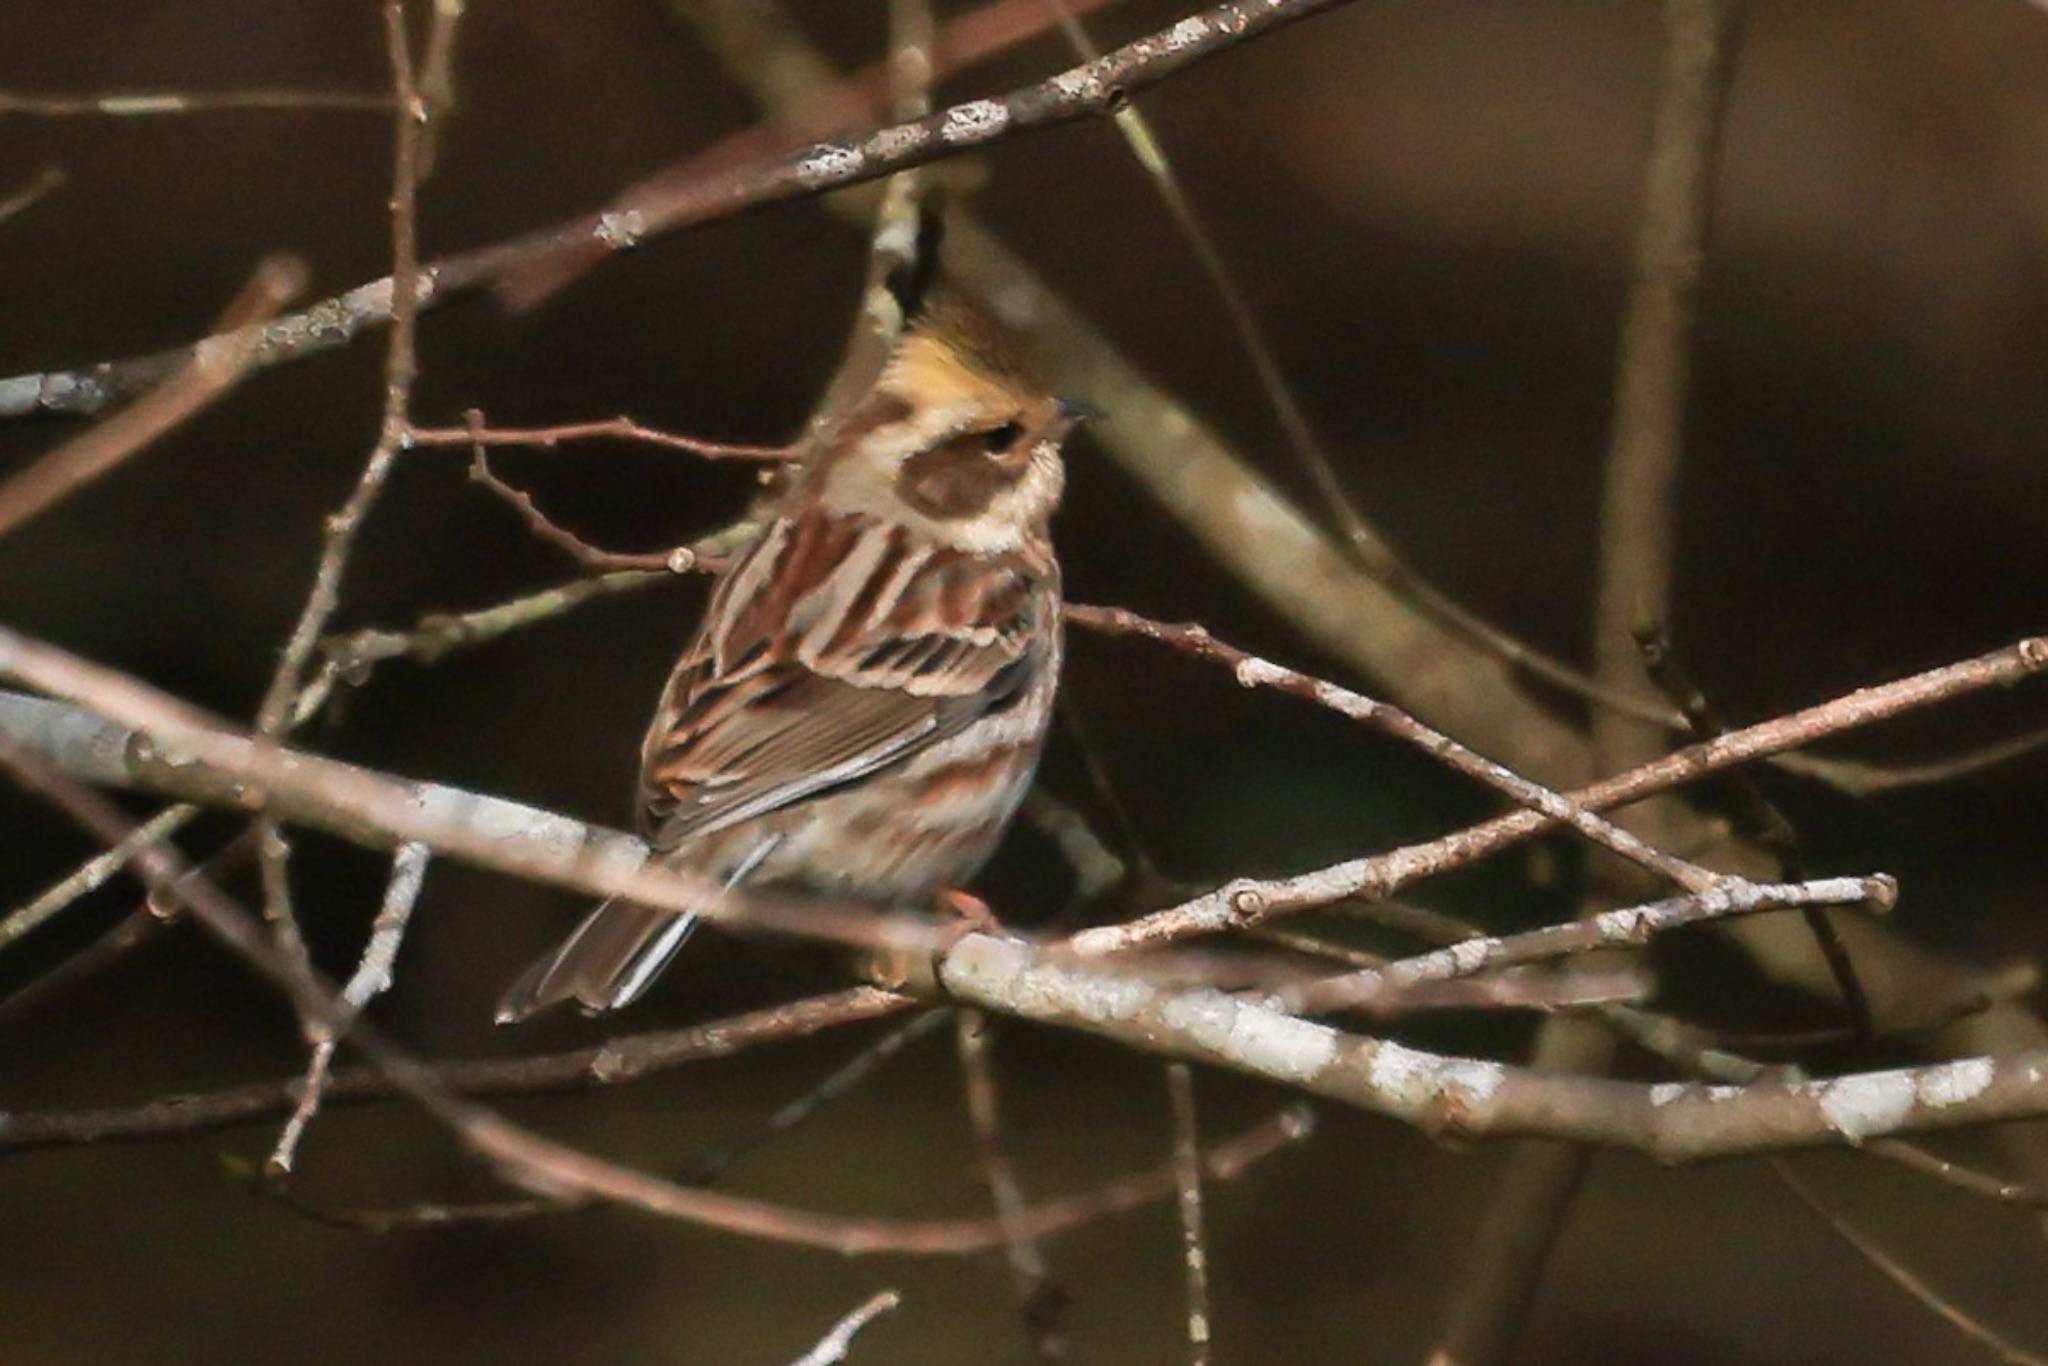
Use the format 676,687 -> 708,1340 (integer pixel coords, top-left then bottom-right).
498,299 -> 1079,1022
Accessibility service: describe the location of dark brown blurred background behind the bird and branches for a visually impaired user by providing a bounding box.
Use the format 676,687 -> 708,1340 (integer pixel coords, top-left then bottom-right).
0,0 -> 2048,1366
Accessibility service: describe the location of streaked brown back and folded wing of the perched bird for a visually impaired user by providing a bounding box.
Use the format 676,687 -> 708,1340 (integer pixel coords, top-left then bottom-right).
639,514 -> 1057,850
